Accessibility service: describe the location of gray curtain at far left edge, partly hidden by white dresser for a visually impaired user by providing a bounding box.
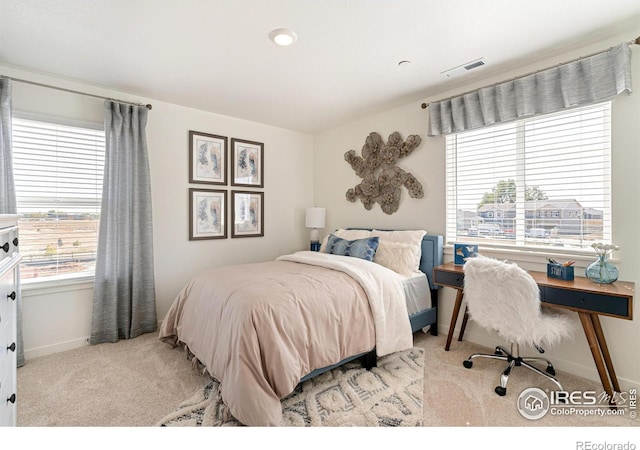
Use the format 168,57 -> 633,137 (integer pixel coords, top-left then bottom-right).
0,77 -> 24,367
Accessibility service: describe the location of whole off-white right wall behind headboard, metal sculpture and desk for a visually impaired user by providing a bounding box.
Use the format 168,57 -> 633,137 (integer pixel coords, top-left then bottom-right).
314,29 -> 640,389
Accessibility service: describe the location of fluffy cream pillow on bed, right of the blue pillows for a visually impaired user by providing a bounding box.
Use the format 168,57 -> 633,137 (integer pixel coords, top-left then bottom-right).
371,230 -> 427,276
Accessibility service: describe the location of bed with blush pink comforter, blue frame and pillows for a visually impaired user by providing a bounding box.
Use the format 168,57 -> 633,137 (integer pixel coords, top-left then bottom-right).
159,229 -> 442,426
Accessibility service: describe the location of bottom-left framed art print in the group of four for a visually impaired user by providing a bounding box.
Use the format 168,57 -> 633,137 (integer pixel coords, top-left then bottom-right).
189,189 -> 227,241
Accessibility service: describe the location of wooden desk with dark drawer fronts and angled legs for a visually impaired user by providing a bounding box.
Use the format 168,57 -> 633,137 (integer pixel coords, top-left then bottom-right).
433,263 -> 635,397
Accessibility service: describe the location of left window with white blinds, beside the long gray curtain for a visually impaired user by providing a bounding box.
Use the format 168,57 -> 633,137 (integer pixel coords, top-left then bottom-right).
12,117 -> 104,282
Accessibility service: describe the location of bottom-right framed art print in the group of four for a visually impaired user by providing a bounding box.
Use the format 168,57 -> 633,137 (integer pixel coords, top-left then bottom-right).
231,191 -> 264,238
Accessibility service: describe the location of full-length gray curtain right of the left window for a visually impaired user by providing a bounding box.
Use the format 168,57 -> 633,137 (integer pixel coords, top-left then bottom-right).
90,100 -> 157,344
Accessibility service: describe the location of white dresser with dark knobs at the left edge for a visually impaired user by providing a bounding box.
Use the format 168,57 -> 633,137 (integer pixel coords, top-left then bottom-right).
0,214 -> 21,426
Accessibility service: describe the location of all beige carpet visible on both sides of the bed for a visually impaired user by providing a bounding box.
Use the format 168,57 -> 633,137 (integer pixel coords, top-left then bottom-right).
17,332 -> 640,427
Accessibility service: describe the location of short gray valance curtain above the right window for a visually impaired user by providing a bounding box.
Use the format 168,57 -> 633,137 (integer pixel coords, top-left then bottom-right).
428,43 -> 631,136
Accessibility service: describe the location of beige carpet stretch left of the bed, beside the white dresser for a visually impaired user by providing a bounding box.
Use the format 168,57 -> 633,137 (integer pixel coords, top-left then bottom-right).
17,333 -> 210,427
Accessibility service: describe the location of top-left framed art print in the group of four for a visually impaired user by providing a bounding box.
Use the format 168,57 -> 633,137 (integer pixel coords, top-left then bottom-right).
189,131 -> 227,185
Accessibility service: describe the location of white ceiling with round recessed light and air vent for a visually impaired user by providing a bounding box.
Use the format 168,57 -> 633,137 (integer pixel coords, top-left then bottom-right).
0,0 -> 640,133
